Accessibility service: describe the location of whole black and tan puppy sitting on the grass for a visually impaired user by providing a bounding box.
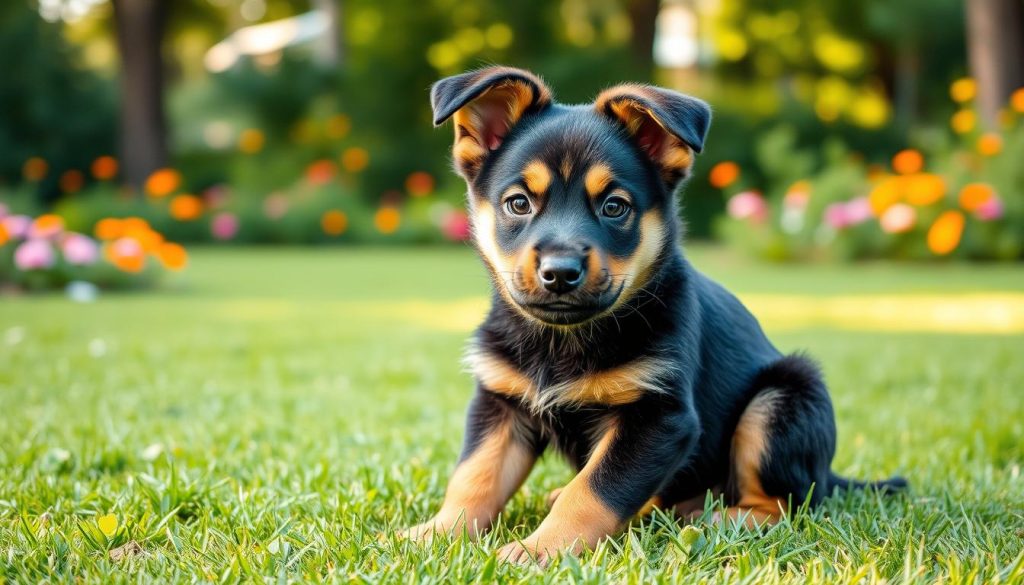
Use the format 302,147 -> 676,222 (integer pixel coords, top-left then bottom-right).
407,68 -> 903,561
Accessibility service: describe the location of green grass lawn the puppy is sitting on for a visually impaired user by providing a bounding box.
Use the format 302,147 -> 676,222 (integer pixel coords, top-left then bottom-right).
0,244 -> 1024,583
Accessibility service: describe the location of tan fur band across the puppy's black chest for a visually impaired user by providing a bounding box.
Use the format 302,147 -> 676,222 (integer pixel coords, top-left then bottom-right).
467,351 -> 669,411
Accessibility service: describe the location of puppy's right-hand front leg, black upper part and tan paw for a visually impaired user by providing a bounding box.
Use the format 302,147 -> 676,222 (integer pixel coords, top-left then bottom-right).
498,403 -> 698,565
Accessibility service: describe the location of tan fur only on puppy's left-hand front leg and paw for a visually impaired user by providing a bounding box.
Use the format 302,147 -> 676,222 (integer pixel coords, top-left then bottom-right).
406,422 -> 536,540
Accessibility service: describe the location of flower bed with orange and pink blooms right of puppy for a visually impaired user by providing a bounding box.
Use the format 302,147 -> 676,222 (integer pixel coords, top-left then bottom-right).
709,80 -> 1024,260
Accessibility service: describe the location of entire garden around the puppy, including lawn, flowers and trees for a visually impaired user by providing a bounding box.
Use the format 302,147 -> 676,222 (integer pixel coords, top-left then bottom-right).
0,0 -> 1024,582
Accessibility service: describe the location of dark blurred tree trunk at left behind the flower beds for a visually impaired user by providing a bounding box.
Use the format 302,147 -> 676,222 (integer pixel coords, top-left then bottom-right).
113,0 -> 168,192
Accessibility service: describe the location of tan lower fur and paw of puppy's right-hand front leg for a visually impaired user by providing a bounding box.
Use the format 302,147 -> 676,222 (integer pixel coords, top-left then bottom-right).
499,425 -> 623,563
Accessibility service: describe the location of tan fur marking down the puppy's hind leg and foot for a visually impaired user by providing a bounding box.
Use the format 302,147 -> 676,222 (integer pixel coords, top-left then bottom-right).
725,390 -> 787,526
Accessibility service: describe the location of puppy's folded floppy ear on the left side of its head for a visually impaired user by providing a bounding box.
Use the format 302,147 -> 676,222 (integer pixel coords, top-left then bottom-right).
430,67 -> 551,180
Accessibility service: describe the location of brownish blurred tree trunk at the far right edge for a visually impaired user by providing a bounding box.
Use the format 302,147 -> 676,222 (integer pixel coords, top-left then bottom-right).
967,0 -> 1024,128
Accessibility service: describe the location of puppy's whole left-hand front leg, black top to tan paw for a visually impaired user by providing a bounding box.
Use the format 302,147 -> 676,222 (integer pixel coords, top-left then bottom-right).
402,388 -> 544,540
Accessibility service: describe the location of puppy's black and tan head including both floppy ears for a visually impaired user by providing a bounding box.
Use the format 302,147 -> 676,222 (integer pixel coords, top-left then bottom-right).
431,67 -> 711,326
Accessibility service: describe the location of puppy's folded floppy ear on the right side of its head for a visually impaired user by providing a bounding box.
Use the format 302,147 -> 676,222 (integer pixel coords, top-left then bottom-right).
594,84 -> 711,190
